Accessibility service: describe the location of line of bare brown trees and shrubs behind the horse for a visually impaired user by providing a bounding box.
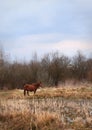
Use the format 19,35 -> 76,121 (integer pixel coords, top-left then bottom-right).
0,50 -> 92,89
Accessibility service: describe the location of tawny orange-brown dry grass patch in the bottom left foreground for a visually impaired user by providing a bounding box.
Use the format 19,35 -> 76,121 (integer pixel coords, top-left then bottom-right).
0,112 -> 59,130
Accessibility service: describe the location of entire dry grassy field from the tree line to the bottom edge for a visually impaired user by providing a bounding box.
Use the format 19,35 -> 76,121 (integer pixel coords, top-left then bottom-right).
0,84 -> 92,130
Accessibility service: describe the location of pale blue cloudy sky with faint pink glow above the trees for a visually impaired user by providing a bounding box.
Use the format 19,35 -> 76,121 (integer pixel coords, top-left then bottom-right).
0,0 -> 92,60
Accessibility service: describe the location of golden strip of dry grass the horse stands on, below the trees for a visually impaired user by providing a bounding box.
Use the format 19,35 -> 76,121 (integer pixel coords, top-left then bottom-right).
0,84 -> 92,99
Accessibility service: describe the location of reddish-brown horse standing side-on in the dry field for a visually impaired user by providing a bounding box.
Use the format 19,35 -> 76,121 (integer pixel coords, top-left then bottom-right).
24,82 -> 42,96
